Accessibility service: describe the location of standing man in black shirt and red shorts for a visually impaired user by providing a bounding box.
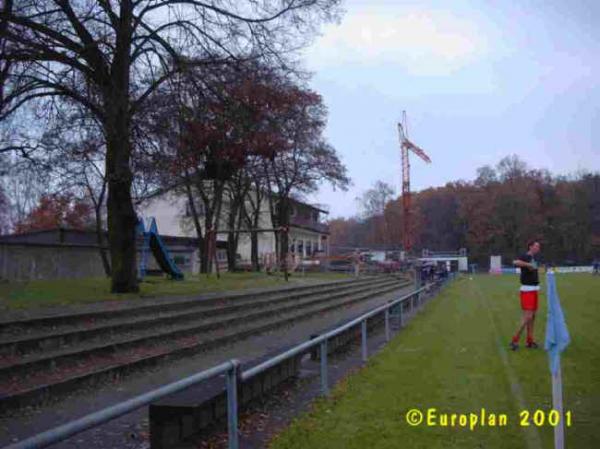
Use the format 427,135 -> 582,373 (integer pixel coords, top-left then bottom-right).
510,240 -> 541,351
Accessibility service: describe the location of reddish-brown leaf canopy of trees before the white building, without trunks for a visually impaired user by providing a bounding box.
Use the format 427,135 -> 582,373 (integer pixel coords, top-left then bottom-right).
173,69 -> 323,179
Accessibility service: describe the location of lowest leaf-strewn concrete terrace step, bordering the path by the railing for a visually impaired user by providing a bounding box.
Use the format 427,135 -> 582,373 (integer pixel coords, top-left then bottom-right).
0,279 -> 406,410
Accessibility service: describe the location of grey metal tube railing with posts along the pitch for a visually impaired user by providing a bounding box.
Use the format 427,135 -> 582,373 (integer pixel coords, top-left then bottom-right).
3,279 -> 452,449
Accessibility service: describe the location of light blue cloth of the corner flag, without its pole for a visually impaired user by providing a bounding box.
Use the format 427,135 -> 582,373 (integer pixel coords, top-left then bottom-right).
544,271 -> 571,374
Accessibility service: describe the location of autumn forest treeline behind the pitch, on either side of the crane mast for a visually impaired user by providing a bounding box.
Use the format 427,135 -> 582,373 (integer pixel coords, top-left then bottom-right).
330,155 -> 600,266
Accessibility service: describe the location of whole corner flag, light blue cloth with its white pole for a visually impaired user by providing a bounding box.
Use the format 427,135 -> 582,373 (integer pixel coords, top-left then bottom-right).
544,271 -> 571,449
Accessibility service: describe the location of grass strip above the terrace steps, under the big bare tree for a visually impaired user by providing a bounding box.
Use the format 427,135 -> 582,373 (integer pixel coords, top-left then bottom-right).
0,272 -> 348,309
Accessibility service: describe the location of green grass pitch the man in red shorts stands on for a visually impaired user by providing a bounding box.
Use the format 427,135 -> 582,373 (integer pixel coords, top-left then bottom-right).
271,274 -> 600,449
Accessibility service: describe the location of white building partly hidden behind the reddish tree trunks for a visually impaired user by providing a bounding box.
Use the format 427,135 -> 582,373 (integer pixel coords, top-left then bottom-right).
137,185 -> 329,271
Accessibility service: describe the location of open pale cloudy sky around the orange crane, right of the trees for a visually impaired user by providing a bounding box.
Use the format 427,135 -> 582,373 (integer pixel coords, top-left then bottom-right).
304,0 -> 600,218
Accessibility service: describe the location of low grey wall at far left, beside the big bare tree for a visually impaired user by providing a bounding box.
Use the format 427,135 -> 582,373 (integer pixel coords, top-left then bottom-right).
0,243 -> 104,281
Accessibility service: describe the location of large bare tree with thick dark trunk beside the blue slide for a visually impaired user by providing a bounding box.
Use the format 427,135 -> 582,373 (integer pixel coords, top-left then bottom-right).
0,0 -> 339,292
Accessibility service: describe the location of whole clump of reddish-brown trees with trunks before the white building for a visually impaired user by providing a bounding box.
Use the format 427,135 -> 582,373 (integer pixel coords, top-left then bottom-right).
148,64 -> 348,272
